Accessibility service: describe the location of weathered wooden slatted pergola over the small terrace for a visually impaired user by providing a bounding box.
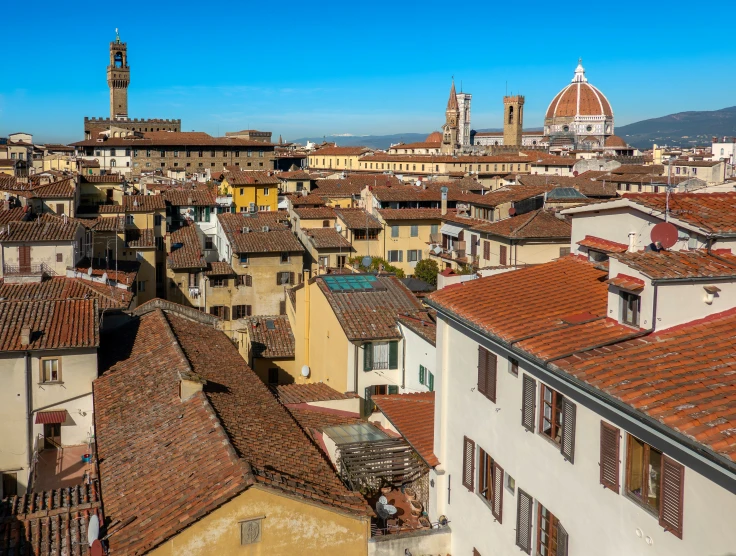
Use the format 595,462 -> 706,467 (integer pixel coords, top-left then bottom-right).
338,438 -> 426,490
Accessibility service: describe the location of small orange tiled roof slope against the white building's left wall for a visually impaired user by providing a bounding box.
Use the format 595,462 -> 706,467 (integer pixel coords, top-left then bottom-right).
371,392 -> 440,467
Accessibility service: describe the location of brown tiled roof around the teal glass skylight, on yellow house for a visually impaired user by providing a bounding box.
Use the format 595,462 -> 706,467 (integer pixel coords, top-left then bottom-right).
316,274 -> 422,341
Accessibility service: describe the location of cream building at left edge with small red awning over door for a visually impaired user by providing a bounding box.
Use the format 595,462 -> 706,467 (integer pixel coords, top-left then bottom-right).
0,299 -> 99,498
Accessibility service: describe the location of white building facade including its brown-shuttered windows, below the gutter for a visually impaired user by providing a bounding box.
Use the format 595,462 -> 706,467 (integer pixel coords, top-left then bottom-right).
430,317 -> 736,556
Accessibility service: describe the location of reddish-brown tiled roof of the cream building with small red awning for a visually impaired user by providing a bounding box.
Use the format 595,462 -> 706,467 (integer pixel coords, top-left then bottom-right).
0,300 -> 100,351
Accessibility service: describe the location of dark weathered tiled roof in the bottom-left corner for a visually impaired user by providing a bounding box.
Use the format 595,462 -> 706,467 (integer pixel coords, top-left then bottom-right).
0,481 -> 104,556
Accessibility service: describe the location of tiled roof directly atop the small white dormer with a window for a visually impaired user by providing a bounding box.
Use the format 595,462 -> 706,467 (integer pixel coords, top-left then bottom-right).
611,250 -> 736,280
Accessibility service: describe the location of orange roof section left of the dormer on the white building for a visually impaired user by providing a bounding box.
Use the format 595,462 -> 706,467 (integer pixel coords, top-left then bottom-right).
428,256 -> 636,360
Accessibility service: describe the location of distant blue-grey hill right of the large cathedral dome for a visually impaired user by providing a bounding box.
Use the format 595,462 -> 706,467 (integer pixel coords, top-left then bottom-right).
616,106 -> 736,149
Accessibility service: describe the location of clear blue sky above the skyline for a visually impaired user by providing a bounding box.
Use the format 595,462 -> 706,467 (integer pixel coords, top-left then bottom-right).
0,0 -> 736,142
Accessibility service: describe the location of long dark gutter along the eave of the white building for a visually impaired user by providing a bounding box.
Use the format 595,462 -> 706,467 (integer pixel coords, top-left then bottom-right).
427,300 -> 736,481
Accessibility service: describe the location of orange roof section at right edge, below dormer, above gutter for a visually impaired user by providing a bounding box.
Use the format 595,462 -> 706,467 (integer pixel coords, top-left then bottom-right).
556,310 -> 736,461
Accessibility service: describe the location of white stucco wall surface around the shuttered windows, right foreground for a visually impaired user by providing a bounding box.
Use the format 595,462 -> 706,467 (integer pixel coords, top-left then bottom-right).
430,319 -> 736,556
